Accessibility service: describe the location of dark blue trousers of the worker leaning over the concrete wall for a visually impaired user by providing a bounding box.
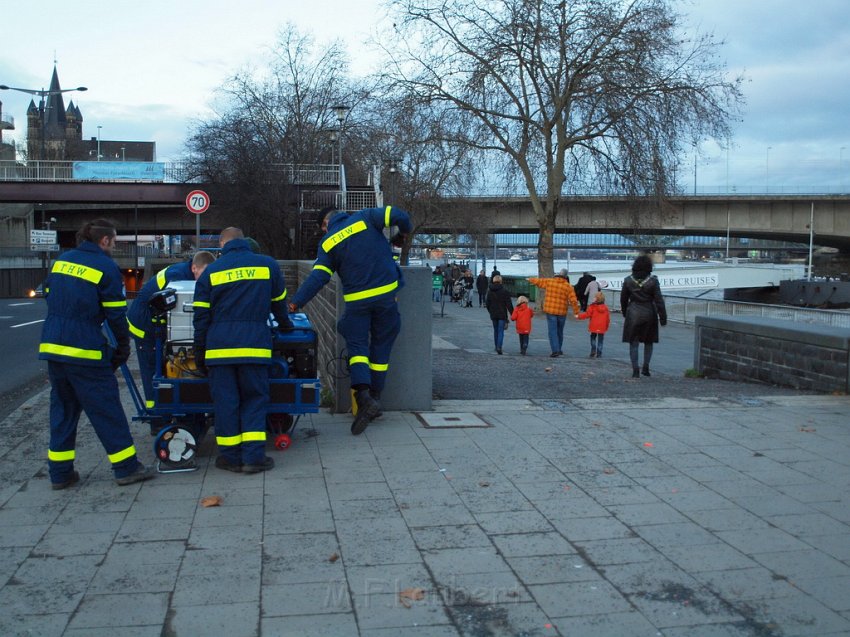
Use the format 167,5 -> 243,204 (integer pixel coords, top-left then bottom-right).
337,296 -> 401,392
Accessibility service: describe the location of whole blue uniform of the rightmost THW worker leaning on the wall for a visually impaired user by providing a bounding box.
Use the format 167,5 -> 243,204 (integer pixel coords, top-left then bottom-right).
292,206 -> 411,392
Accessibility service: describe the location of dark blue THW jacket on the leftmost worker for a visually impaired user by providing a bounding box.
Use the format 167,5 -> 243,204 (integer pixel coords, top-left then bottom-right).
38,241 -> 130,366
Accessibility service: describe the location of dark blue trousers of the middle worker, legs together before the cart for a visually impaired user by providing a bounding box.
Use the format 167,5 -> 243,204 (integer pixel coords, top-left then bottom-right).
209,363 -> 269,464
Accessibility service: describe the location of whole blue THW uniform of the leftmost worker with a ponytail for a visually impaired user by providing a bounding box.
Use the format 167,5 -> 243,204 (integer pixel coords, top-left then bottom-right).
38,241 -> 139,484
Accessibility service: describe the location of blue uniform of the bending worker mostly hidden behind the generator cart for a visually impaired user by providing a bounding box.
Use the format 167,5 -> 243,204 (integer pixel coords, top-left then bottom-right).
127,261 -> 195,414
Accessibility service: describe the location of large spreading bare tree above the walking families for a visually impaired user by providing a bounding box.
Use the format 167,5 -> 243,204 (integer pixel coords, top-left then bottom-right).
385,0 -> 742,276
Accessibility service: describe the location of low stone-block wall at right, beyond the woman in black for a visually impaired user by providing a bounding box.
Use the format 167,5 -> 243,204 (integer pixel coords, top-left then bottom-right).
694,316 -> 850,393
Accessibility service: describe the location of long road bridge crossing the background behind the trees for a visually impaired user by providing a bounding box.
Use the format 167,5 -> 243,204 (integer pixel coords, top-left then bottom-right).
0,162 -> 850,252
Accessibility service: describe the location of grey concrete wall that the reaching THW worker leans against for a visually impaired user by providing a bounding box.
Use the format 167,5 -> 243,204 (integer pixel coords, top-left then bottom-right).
286,261 -> 433,413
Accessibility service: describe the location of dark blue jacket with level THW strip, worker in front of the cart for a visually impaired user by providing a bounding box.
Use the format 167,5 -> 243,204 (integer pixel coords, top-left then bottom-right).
193,239 -> 292,366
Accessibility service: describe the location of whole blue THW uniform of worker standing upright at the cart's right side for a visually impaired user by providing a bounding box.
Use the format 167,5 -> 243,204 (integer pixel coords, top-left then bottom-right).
193,239 -> 292,465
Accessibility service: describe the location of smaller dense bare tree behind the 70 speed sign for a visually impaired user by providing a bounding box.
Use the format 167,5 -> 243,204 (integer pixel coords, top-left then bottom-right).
187,25 -> 360,257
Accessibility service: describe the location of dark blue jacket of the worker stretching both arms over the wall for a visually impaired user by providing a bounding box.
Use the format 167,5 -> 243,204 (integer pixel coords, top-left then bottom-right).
292,206 -> 412,307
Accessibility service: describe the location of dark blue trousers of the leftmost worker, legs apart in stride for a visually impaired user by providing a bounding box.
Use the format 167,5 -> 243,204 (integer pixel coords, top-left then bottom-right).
47,361 -> 139,482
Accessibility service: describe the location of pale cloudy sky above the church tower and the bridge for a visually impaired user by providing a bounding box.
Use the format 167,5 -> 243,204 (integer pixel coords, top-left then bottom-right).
0,0 -> 850,194
